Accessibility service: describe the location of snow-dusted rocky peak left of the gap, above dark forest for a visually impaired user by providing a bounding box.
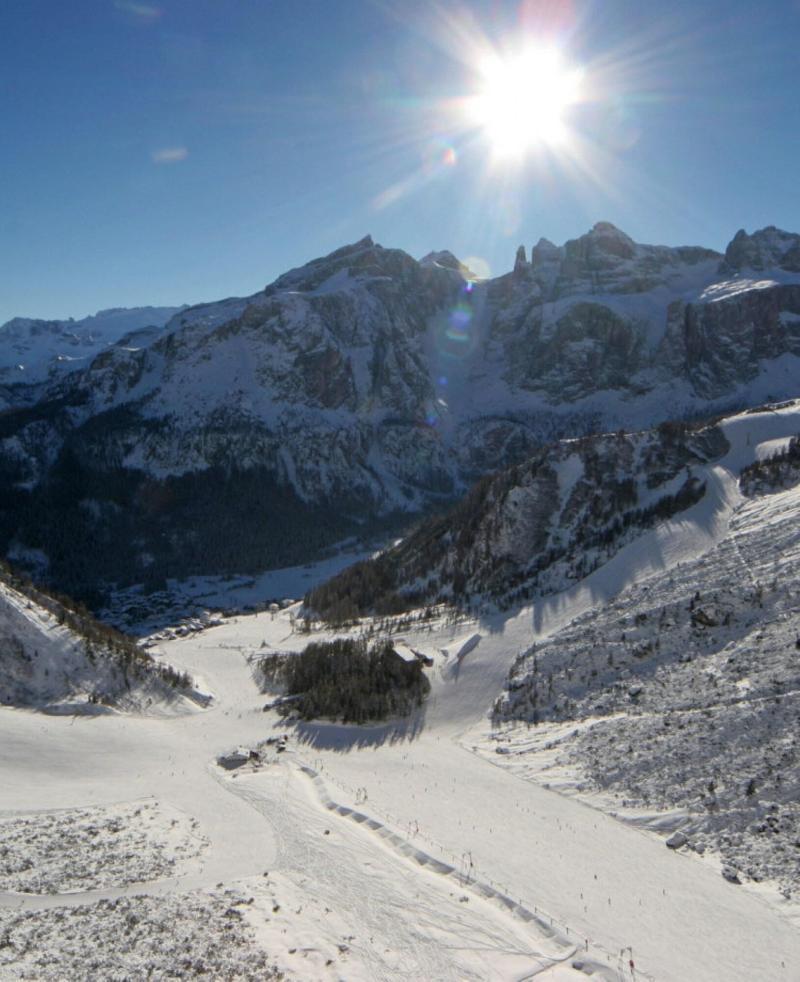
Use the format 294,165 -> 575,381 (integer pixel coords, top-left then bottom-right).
54,238 -> 464,503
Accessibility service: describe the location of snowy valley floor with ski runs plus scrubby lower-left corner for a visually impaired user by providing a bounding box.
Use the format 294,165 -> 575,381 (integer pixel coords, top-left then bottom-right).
0,404 -> 800,982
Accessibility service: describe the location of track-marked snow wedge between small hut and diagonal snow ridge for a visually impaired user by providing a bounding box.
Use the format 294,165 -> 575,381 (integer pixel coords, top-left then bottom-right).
219,768 -> 585,982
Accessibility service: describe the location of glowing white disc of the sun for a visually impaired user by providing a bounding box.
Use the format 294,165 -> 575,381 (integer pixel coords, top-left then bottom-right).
469,48 -> 582,157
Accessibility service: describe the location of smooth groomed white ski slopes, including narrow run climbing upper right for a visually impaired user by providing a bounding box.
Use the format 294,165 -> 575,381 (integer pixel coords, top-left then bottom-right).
0,408 -> 800,982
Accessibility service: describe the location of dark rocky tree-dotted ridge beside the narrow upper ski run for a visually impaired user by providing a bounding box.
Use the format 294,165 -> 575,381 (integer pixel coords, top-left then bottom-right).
307,424 -> 730,621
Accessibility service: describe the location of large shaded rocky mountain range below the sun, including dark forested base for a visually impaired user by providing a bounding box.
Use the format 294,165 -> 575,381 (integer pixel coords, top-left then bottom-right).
0,229 -> 800,592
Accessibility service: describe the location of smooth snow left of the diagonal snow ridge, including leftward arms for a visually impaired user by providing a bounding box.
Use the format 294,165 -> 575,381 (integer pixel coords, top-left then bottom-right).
0,618 -> 588,982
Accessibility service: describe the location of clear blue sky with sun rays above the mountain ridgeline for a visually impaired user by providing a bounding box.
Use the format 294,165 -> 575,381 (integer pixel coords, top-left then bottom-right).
0,0 -> 800,323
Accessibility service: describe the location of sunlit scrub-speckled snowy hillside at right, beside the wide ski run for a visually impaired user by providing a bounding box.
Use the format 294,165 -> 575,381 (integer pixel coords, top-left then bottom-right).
487,412 -> 800,898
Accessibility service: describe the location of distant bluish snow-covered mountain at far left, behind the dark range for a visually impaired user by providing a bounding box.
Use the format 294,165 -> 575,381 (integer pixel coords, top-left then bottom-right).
0,307 -> 183,403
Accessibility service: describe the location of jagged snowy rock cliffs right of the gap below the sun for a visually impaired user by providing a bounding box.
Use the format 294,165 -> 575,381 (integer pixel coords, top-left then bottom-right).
490,222 -> 800,404
